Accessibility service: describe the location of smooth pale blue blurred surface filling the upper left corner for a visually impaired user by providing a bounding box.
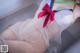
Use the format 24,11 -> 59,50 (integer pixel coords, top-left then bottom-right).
0,0 -> 39,18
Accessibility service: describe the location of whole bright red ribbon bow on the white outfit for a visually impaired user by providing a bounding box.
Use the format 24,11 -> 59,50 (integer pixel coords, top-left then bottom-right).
38,4 -> 54,27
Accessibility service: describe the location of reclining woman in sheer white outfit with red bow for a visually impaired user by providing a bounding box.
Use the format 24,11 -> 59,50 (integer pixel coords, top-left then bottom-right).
2,0 -> 78,53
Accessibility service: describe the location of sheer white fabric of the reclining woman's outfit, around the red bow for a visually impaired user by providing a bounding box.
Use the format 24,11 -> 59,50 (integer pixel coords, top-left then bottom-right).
11,0 -> 76,45
